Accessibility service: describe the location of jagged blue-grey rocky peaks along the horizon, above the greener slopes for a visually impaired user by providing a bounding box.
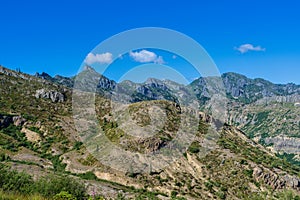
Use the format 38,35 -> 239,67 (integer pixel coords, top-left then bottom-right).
35,67 -> 300,104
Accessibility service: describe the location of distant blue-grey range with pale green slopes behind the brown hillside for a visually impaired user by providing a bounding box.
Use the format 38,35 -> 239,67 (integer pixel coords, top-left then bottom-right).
12,67 -> 300,163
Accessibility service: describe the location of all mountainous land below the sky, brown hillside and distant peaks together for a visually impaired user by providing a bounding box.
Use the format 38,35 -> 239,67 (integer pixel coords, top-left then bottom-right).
0,67 -> 300,199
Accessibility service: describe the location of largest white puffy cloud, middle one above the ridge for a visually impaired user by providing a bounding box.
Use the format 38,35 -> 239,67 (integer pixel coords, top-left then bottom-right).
129,50 -> 165,64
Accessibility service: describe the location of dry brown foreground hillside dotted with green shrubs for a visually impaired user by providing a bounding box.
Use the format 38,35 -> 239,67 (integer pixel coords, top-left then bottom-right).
0,65 -> 300,199
